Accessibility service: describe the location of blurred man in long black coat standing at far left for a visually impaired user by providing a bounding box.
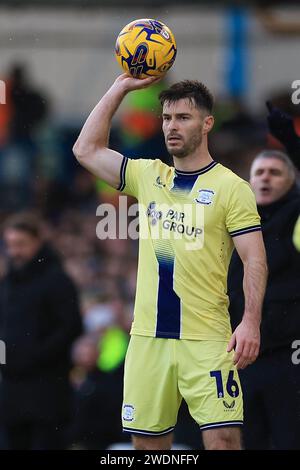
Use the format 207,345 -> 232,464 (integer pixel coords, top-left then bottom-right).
0,214 -> 81,449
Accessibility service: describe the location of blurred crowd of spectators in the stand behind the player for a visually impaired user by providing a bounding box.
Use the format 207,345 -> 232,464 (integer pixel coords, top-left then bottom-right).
0,64 -> 300,449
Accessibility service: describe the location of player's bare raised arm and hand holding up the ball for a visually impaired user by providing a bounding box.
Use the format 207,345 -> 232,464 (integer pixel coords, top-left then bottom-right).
73,74 -> 158,188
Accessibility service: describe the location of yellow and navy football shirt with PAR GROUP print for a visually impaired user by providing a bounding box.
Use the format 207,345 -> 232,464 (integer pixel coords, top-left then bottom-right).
119,157 -> 260,341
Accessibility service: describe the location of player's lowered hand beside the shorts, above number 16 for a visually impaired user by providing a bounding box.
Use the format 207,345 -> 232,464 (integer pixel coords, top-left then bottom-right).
227,319 -> 260,369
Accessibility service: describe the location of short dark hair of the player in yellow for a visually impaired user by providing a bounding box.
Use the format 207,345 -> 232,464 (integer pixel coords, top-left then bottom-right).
159,80 -> 214,114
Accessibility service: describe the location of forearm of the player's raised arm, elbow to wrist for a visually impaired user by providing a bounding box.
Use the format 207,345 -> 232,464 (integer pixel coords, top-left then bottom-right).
74,85 -> 126,156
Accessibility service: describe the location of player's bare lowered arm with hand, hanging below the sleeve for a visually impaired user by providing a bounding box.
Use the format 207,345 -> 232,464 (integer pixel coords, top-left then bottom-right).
227,232 -> 268,369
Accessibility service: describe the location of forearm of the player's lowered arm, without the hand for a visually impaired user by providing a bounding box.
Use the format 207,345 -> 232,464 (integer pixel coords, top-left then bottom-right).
243,258 -> 268,325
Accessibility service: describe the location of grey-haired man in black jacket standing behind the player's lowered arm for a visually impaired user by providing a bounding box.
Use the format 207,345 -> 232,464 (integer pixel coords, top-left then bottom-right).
228,150 -> 300,449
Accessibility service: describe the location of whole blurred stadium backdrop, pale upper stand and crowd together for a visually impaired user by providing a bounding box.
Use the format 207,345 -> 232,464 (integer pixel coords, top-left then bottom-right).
0,0 -> 300,448
